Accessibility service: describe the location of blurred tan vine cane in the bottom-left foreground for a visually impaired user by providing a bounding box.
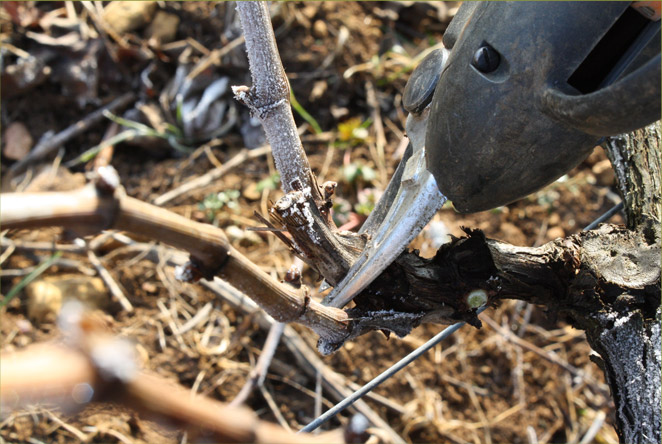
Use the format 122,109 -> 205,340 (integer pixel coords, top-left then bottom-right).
0,303 -> 343,443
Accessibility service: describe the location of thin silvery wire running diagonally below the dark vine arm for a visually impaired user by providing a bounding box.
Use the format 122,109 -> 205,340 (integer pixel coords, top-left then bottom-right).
299,306 -> 487,432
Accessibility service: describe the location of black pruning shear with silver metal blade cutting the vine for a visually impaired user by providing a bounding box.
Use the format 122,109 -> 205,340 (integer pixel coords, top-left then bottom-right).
323,2 -> 661,307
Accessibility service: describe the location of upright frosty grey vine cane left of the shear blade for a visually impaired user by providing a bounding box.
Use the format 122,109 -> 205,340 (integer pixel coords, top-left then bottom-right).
233,1 -> 365,285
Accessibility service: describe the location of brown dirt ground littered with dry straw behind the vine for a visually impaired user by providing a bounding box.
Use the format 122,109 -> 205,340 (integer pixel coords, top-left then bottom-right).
0,2 -> 622,443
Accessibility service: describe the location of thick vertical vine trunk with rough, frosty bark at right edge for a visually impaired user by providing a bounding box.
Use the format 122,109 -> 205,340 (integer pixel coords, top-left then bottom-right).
586,122 -> 662,443
